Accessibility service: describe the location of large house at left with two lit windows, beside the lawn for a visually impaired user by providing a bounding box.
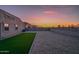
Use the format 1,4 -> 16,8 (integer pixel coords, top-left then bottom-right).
0,9 -> 24,40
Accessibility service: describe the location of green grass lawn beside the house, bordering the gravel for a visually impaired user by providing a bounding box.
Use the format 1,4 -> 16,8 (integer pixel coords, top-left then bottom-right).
0,33 -> 36,54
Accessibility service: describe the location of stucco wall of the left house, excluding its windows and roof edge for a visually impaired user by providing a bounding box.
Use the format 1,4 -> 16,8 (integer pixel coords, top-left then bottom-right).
0,9 -> 24,39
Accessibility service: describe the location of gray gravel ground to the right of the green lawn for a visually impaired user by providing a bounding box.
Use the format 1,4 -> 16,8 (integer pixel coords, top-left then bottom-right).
29,31 -> 79,54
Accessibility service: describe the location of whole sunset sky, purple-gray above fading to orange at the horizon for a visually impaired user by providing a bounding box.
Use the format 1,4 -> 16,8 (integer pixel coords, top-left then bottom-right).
0,5 -> 79,27
